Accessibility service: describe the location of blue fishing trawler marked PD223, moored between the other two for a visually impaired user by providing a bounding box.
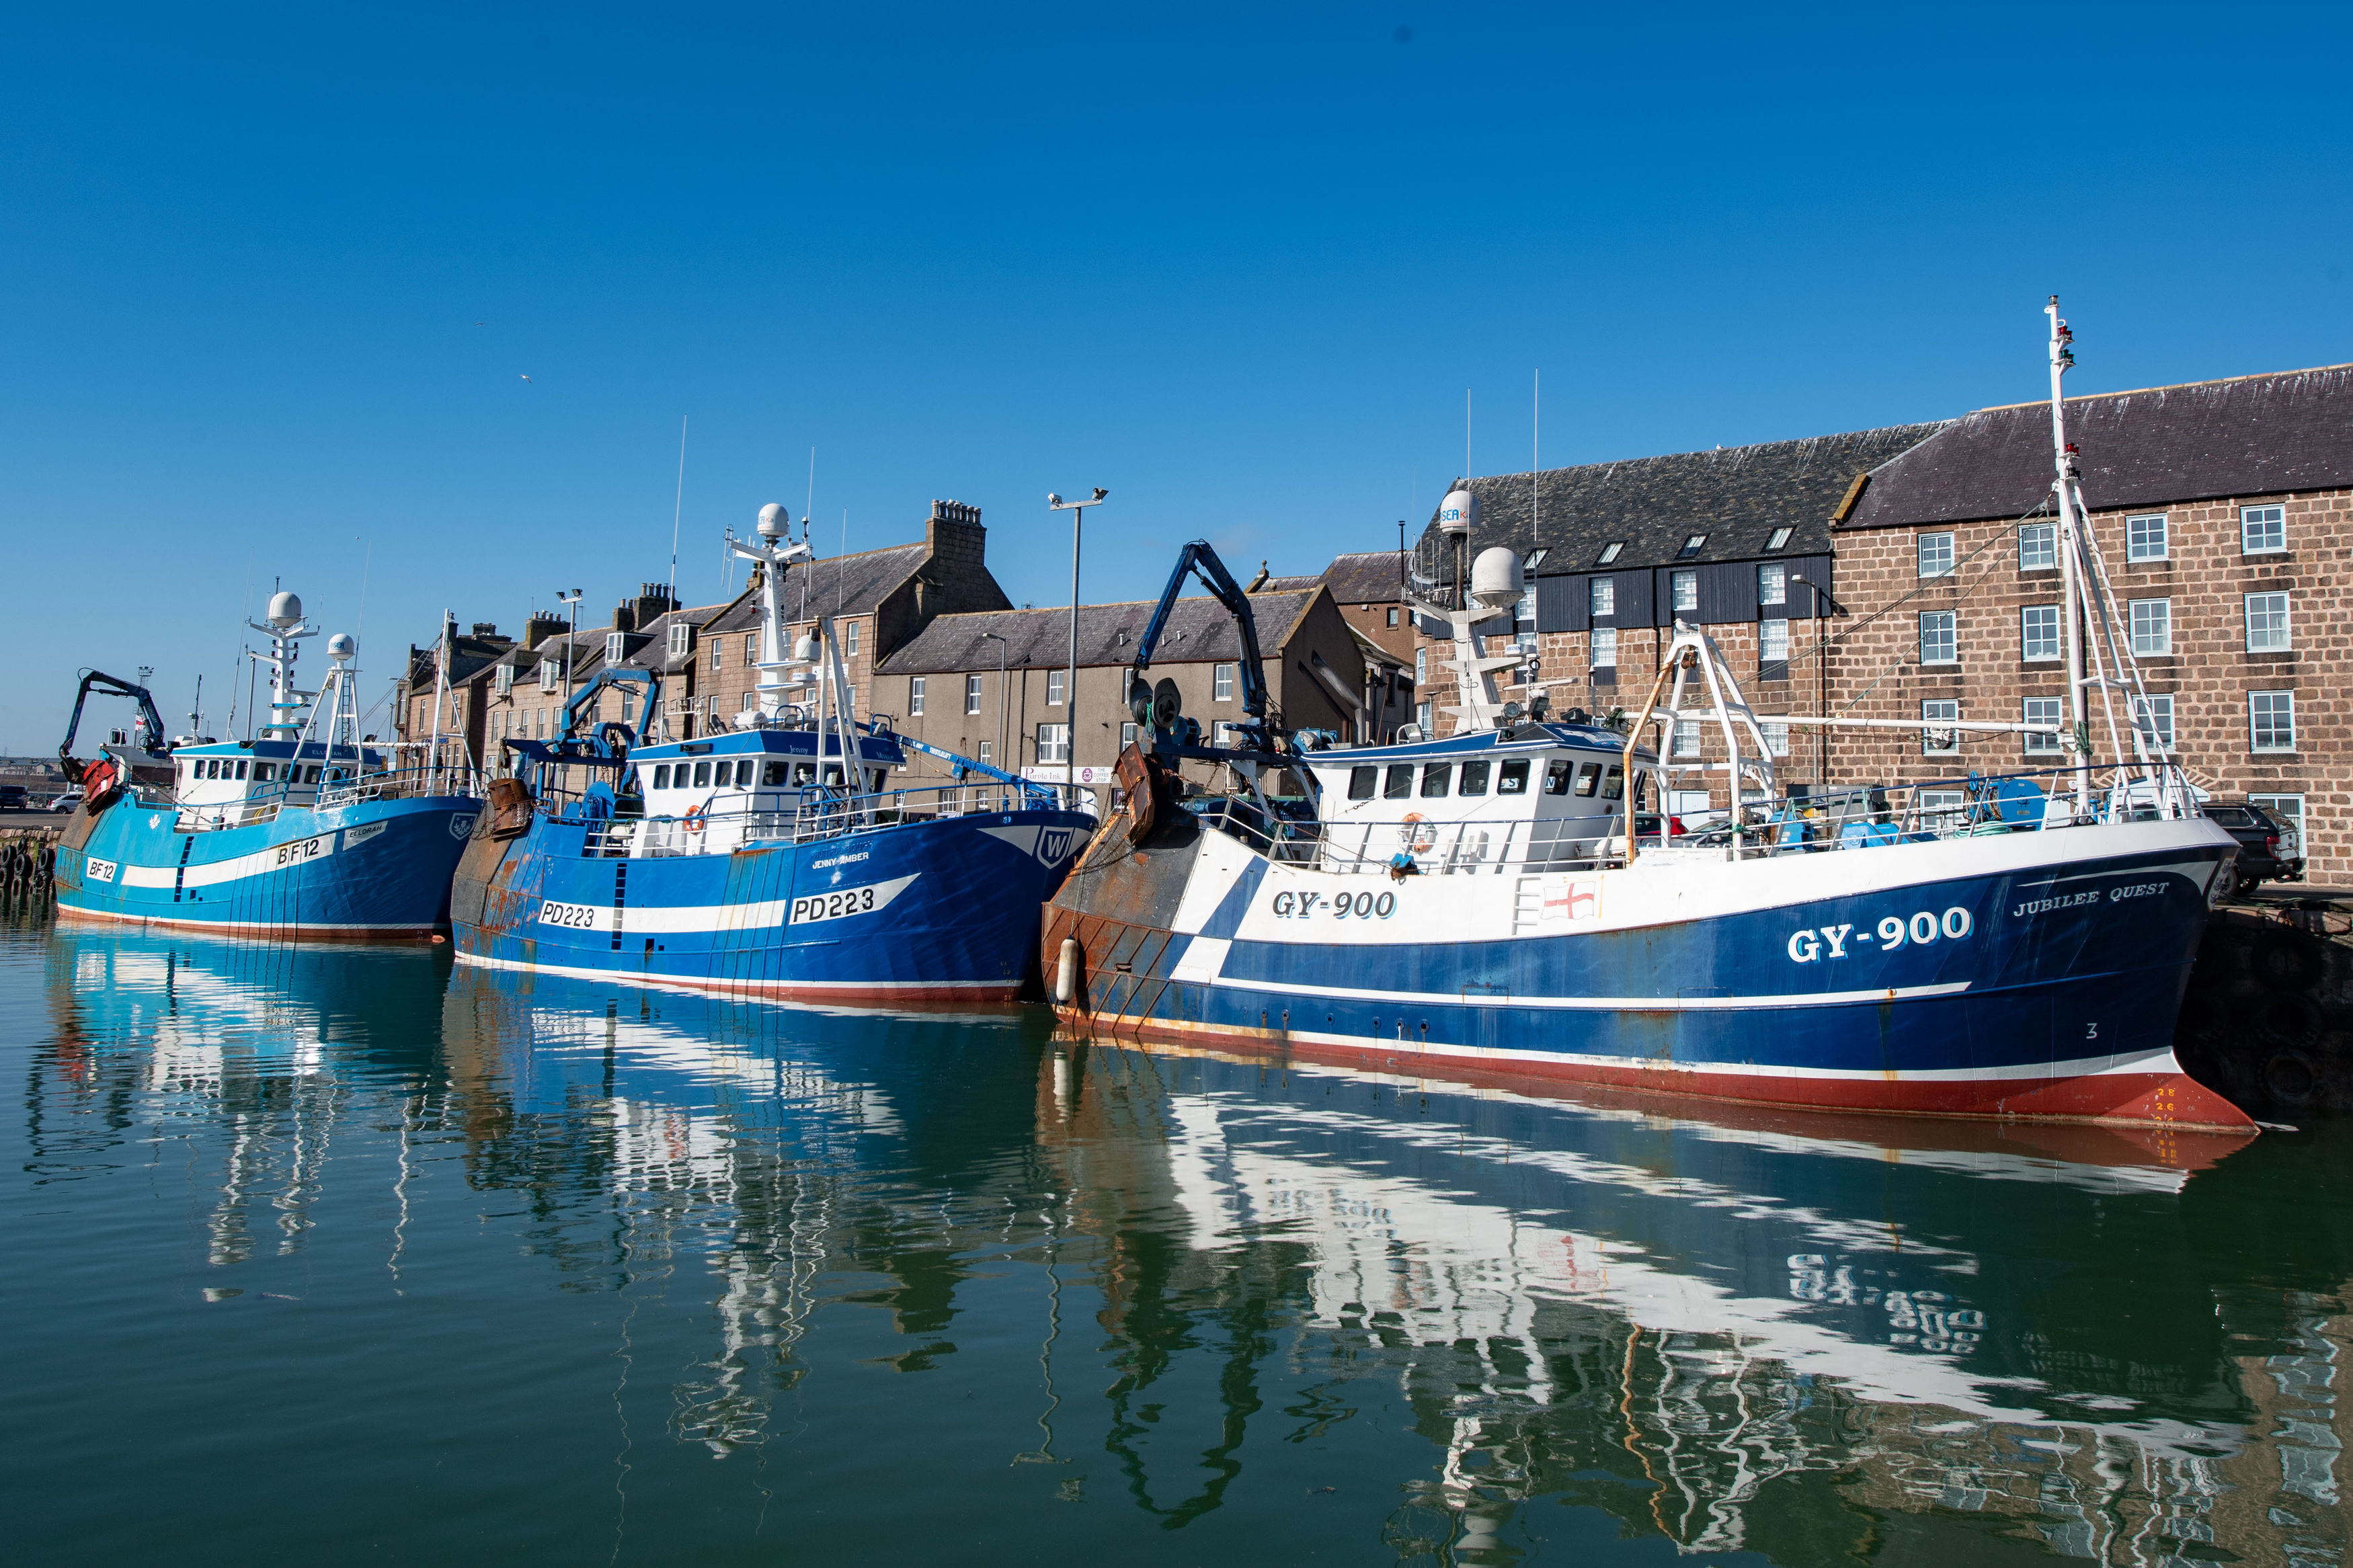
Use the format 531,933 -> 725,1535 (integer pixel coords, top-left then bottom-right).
452,505 -> 1094,1001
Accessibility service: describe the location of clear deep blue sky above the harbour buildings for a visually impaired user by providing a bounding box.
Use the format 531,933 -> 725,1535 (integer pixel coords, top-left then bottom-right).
0,5 -> 2353,752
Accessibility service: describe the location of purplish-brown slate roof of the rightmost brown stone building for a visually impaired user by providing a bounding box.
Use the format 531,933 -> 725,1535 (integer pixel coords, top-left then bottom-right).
1845,364 -> 2353,531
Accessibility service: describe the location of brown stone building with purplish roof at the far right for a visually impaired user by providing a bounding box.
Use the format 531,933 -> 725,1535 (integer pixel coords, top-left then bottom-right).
1831,364 -> 2353,884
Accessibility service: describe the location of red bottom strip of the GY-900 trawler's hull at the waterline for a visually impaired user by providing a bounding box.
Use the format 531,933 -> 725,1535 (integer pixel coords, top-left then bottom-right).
1057,1009 -> 2257,1133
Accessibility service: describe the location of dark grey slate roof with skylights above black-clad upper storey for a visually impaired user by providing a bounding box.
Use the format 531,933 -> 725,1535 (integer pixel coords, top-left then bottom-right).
1414,421 -> 1946,576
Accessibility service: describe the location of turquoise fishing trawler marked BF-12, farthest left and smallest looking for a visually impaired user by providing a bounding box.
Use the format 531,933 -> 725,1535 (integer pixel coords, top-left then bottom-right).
56,592 -> 480,938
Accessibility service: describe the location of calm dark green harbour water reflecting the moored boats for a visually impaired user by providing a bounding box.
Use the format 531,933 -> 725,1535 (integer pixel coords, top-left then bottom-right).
0,926 -> 2353,1568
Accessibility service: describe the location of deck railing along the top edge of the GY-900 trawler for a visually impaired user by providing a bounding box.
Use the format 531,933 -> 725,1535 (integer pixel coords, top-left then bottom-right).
1261,766 -> 2202,877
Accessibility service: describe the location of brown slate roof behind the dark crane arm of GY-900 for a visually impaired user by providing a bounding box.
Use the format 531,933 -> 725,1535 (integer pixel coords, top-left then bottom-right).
875,590 -> 1316,675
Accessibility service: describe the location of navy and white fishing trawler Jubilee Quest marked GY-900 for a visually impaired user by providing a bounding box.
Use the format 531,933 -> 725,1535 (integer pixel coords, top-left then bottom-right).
1045,313 -> 2249,1128
